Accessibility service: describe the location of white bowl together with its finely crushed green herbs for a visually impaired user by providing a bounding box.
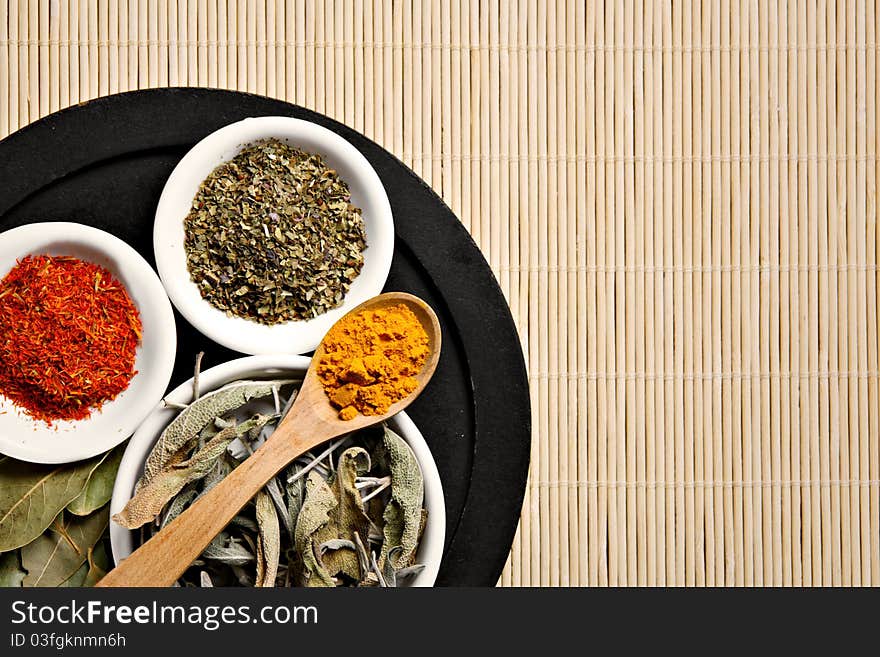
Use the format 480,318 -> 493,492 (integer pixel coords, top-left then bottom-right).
153,116 -> 394,354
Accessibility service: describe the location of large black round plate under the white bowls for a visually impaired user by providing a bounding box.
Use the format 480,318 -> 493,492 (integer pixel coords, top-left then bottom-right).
0,89 -> 530,586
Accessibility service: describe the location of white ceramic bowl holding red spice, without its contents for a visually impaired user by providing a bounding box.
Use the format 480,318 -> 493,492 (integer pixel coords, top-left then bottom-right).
0,222 -> 177,463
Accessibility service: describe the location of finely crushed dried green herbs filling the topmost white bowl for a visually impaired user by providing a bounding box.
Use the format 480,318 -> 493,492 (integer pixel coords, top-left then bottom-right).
184,139 -> 366,324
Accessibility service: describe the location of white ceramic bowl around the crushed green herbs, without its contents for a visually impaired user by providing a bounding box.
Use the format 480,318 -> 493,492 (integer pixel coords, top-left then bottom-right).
153,116 -> 394,354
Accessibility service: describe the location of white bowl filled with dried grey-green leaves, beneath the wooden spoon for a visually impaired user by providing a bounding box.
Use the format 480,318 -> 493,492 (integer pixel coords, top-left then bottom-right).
110,355 -> 446,587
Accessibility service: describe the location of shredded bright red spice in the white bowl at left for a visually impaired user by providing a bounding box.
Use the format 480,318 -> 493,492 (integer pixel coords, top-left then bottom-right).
0,255 -> 142,424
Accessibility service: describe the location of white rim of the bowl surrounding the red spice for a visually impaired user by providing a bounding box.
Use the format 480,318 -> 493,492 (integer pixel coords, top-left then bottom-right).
0,221 -> 177,464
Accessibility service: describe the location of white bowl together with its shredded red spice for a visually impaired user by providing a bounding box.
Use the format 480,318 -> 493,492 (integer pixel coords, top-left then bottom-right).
0,222 -> 177,463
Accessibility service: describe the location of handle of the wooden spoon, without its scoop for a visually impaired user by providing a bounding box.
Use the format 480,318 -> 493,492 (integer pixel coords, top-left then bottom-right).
97,427 -> 306,586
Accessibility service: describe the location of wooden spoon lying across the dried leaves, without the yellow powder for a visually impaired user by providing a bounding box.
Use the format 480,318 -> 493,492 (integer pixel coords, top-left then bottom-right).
98,292 -> 440,586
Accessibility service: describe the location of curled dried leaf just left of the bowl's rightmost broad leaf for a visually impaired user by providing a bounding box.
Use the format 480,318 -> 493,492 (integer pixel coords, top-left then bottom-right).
313,447 -> 370,582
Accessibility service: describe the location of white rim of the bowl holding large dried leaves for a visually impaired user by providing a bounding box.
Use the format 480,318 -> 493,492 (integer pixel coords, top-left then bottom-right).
110,355 -> 446,587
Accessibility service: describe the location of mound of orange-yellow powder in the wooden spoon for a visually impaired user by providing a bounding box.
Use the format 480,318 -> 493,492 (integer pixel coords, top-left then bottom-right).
318,304 -> 428,420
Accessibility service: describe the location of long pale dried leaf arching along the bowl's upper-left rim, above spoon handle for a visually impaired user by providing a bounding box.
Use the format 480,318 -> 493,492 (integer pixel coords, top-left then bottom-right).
141,381 -> 290,485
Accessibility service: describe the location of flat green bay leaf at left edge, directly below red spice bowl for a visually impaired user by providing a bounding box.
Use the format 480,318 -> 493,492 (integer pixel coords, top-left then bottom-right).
0,456 -> 102,552
